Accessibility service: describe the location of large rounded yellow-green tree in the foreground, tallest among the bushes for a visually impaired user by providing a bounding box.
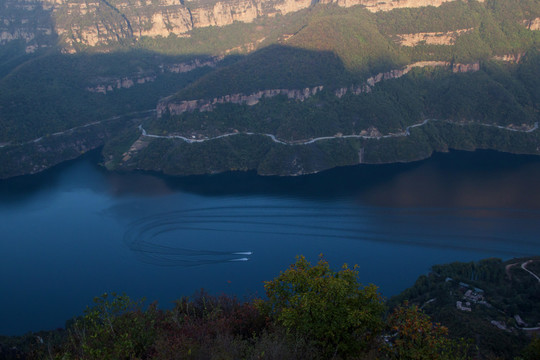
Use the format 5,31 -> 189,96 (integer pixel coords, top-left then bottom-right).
263,256 -> 384,358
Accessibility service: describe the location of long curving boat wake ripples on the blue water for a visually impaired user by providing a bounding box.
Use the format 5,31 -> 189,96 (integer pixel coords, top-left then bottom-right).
124,205 -> 539,266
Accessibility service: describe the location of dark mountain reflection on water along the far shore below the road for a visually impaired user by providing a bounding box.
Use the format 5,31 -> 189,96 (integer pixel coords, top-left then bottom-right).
112,151 -> 540,205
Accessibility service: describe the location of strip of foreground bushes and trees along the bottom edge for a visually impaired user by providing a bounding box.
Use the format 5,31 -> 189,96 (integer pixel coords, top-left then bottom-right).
4,257 -> 476,360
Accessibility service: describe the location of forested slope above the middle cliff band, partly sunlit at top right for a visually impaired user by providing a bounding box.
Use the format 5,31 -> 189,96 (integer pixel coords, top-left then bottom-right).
172,0 -> 540,99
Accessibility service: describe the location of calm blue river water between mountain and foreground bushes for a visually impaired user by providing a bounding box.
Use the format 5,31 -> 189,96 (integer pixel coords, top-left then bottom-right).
0,152 -> 540,334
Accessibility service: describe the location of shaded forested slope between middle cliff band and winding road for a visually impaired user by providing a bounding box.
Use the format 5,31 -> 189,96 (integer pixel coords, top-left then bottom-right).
152,54 -> 540,140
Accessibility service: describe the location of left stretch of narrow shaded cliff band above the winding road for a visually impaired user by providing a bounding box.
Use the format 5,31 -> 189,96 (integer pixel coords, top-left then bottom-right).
156,86 -> 323,117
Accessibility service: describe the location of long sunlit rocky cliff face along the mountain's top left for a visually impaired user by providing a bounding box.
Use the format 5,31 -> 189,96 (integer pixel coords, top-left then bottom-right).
0,0 -> 464,52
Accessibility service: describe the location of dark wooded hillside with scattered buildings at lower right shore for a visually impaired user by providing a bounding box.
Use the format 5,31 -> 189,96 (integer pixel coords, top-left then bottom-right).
390,258 -> 540,359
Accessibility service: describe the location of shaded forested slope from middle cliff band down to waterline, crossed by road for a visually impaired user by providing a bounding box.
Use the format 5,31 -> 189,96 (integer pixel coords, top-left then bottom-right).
104,52 -> 540,175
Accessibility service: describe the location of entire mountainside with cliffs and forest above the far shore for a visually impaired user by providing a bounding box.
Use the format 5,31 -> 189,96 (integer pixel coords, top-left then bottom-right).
0,0 -> 540,178
